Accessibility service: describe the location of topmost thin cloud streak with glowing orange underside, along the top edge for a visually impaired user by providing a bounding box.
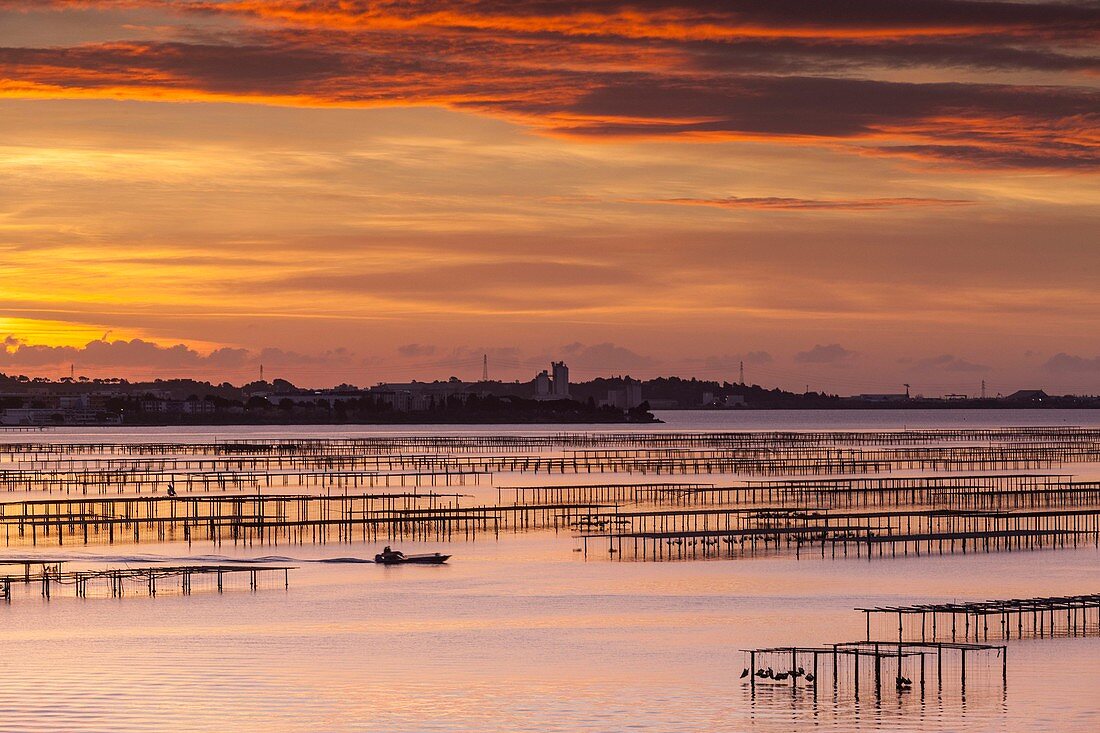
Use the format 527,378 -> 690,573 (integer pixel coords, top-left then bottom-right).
191,0 -> 1098,41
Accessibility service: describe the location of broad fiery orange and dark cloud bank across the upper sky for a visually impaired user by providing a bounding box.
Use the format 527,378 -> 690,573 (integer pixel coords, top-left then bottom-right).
0,0 -> 1100,168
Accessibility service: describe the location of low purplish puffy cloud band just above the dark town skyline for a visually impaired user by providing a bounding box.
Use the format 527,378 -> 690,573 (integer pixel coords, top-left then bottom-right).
0,340 -> 1100,397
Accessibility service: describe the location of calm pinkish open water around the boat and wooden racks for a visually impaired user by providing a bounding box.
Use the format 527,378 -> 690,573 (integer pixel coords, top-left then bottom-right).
0,411 -> 1100,732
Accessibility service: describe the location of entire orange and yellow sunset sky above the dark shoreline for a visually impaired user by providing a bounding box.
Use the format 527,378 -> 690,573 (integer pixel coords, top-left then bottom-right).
0,0 -> 1100,394
